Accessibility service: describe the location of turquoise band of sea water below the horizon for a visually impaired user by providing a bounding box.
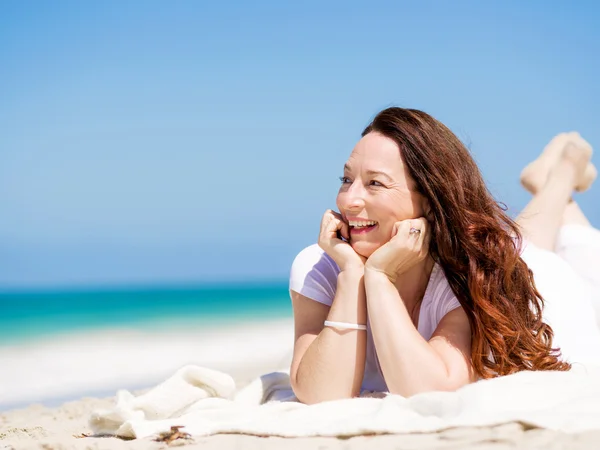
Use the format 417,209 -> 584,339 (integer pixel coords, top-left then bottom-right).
0,282 -> 292,344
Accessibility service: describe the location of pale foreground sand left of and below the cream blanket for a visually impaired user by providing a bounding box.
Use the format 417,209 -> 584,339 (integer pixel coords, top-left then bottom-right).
0,388 -> 600,450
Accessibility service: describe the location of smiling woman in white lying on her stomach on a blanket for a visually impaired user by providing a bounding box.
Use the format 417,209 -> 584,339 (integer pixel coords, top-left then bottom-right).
290,108 -> 600,403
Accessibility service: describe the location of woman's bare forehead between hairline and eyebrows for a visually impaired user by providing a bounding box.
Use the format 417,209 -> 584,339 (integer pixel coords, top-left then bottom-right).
347,133 -> 404,171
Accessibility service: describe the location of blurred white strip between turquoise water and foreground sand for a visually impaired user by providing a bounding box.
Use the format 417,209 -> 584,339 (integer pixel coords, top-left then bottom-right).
0,319 -> 293,409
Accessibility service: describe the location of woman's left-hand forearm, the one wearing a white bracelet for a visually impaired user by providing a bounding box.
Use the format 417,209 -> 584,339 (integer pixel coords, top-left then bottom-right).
293,270 -> 367,404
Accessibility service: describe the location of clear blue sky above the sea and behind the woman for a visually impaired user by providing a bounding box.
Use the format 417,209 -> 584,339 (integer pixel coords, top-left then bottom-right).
0,0 -> 600,288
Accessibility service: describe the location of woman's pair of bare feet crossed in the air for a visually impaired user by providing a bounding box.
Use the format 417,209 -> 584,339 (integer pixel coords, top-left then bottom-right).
521,132 -> 597,194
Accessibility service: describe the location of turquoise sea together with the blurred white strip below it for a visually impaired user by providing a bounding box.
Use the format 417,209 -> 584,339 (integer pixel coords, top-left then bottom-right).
0,281 -> 294,411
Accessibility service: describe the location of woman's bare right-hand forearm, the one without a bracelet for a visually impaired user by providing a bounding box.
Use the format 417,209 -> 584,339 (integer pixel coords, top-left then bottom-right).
364,269 -> 449,397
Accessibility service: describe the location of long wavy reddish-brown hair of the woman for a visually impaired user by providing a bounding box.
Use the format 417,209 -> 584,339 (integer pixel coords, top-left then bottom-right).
363,108 -> 571,378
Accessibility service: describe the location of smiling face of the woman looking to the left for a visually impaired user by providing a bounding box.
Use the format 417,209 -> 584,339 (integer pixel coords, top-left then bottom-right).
336,132 -> 426,258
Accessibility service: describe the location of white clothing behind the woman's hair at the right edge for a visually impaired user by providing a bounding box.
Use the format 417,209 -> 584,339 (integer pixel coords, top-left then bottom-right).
522,225 -> 600,364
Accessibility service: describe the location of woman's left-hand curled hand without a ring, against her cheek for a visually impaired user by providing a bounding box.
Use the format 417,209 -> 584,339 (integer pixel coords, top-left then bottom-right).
319,209 -> 367,270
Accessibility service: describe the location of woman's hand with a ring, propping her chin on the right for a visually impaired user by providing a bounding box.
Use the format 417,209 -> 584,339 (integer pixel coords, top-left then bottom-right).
365,217 -> 431,282
